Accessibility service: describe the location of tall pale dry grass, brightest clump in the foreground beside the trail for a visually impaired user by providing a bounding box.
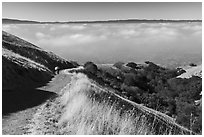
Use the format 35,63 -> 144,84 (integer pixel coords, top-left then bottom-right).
58,74 -> 153,135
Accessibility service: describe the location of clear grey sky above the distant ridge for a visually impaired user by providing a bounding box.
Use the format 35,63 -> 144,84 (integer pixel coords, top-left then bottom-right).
2,2 -> 202,21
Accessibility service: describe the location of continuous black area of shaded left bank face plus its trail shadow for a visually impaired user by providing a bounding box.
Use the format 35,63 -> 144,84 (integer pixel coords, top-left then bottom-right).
2,57 -> 56,115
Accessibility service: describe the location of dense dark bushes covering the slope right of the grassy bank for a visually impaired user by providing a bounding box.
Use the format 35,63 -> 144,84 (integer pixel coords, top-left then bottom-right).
77,61 -> 202,134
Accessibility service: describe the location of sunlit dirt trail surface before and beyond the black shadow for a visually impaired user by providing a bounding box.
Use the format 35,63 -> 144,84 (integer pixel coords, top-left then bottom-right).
2,72 -> 71,135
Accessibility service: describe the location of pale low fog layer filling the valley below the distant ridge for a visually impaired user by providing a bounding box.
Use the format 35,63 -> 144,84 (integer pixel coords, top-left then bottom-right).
3,23 -> 202,65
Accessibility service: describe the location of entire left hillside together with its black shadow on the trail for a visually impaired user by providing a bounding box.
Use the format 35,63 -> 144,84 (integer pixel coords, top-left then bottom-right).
2,31 -> 75,114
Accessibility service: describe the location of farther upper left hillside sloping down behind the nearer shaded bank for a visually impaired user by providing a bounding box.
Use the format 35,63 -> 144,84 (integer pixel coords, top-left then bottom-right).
2,31 -> 74,72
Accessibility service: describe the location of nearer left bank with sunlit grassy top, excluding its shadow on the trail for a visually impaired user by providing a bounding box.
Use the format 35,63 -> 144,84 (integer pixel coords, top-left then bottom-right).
2,49 -> 52,90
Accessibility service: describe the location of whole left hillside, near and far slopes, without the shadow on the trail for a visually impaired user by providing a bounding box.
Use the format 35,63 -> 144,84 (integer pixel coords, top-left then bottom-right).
2,31 -> 76,89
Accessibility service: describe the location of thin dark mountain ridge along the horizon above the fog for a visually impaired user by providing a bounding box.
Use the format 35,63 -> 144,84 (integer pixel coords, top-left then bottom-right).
2,18 -> 202,24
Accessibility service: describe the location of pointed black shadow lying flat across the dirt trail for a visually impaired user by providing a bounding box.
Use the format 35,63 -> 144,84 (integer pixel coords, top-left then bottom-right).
2,88 -> 57,115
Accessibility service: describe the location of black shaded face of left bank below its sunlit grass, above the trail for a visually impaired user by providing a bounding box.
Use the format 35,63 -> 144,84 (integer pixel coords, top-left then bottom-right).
2,56 -> 52,91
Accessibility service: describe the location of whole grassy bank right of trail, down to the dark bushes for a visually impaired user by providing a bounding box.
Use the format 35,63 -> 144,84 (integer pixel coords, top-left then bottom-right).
26,74 -> 194,135
